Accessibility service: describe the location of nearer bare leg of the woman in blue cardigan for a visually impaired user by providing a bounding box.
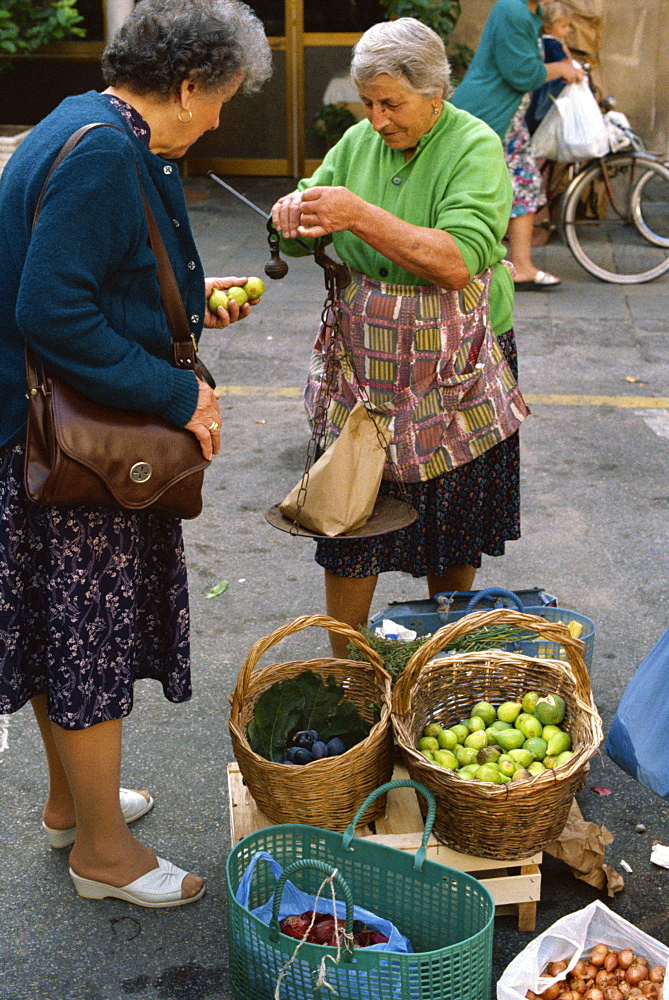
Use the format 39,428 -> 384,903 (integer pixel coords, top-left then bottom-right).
36,704 -> 203,898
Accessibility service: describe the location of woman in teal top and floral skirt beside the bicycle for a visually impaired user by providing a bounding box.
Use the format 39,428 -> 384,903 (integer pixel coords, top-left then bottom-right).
451,0 -> 583,290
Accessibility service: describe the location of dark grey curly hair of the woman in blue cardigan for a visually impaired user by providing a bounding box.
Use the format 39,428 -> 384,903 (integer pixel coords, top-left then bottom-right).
102,0 -> 272,97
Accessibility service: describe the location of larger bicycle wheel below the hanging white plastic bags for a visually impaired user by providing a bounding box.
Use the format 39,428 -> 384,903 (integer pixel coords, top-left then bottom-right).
562,153 -> 669,285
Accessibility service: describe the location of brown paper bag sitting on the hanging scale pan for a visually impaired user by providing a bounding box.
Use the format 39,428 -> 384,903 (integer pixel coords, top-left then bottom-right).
279,403 -> 390,537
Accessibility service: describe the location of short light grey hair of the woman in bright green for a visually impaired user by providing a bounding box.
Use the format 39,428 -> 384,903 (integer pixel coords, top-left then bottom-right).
351,17 -> 451,98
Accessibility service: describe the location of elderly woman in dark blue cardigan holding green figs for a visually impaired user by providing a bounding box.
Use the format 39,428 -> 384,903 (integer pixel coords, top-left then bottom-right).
0,0 -> 271,907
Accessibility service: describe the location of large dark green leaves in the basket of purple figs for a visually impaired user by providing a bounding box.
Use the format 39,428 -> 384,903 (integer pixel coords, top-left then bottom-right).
246,670 -> 371,763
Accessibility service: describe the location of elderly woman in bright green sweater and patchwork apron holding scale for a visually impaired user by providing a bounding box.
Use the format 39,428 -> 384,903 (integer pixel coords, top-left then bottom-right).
272,18 -> 527,655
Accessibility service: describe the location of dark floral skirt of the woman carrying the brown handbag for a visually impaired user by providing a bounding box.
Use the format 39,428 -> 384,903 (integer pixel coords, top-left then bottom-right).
0,445 -> 191,729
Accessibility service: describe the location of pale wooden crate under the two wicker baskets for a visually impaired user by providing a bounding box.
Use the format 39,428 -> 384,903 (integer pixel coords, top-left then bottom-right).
228,762 -> 542,931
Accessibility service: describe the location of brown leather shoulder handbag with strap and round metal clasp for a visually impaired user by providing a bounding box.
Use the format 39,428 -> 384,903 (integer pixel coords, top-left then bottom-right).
24,122 -> 214,518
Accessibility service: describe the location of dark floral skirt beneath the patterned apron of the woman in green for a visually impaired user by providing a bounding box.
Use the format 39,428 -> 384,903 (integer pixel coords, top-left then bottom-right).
316,330 -> 520,577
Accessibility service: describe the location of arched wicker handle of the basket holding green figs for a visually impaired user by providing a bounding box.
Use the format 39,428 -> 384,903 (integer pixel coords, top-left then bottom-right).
393,608 -> 590,715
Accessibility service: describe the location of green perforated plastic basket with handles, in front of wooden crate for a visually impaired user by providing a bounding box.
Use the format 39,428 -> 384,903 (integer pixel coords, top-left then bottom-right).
226,779 -> 495,1000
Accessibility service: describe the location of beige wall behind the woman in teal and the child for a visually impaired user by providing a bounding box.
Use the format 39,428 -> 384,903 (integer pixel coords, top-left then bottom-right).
454,0 -> 669,157
